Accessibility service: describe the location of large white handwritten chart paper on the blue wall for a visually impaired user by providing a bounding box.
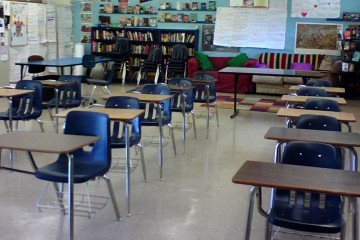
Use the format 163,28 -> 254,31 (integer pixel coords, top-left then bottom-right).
214,0 -> 287,49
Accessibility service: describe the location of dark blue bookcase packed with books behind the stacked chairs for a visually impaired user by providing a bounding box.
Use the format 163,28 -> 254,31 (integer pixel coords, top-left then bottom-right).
91,27 -> 199,67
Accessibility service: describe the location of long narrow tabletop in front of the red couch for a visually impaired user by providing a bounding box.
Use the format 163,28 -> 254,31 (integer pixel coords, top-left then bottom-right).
219,67 -> 323,78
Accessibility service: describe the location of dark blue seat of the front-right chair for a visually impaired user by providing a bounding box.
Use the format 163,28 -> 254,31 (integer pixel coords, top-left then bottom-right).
269,198 -> 342,233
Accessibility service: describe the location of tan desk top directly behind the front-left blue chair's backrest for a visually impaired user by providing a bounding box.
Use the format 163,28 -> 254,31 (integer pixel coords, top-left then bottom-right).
55,107 -> 145,121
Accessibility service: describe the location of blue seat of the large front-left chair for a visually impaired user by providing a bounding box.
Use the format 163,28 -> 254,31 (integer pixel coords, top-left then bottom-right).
35,155 -> 109,183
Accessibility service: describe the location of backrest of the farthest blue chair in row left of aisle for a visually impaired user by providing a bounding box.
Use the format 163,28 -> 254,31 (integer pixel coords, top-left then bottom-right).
193,72 -> 216,102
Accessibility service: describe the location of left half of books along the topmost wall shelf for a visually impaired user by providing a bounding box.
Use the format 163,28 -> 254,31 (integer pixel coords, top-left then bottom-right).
100,4 -> 156,14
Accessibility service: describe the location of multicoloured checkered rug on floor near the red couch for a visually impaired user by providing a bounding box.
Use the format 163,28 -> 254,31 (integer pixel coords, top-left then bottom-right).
201,95 -> 286,113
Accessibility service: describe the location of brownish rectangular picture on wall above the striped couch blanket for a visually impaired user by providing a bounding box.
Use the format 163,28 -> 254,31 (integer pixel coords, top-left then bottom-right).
295,23 -> 343,55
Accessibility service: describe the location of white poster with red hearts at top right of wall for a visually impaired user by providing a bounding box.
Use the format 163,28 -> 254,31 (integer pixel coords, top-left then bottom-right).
291,0 -> 341,18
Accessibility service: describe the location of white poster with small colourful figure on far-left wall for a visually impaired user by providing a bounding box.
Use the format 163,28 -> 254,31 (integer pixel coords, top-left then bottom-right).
10,3 -> 28,46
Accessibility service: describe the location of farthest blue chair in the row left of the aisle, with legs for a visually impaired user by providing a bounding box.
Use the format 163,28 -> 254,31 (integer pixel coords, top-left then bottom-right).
193,72 -> 219,137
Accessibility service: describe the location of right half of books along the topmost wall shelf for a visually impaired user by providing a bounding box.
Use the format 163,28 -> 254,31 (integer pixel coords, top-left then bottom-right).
159,1 -> 216,11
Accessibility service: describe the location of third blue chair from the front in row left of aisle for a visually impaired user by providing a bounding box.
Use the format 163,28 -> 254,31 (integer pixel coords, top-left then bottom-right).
140,84 -> 176,155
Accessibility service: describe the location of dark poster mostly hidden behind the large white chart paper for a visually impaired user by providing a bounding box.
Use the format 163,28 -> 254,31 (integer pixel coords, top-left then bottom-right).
201,25 -> 239,52
